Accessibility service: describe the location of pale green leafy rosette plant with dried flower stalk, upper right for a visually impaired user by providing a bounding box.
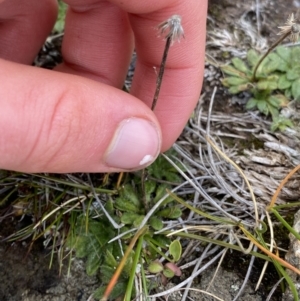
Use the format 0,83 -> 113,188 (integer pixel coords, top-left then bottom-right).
221,14 -> 300,130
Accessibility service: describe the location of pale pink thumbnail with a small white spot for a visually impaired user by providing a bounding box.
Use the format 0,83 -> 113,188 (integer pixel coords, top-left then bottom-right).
105,118 -> 160,170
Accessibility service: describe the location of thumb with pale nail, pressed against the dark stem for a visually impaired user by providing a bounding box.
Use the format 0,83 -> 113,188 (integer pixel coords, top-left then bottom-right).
0,60 -> 161,173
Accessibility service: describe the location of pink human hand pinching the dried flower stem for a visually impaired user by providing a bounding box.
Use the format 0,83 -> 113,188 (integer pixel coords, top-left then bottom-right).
0,0 -> 207,173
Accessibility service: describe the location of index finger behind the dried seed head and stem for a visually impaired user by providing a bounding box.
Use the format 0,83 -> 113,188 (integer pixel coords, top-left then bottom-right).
111,0 -> 207,151
